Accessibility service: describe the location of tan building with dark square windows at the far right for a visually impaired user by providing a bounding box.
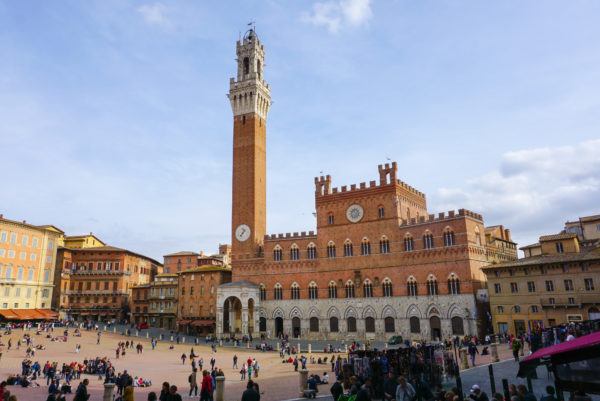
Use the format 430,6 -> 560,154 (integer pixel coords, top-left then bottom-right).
483,232 -> 600,334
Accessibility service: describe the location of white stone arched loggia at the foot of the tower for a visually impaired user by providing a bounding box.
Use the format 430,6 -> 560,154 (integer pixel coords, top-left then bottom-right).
216,281 -> 260,338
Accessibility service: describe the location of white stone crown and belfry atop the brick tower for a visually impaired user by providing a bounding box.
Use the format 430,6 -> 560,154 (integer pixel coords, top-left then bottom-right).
228,29 -> 271,120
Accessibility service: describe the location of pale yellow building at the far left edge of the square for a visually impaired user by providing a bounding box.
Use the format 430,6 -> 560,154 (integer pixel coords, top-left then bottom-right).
0,215 -> 64,312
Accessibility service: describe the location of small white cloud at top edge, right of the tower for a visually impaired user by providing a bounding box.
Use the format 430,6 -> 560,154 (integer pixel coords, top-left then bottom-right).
303,0 -> 373,33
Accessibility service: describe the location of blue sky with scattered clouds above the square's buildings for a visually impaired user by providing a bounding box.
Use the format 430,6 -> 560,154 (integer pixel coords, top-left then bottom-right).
0,0 -> 600,260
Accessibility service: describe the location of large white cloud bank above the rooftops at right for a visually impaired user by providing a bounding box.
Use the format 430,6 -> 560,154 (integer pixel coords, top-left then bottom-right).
438,139 -> 600,245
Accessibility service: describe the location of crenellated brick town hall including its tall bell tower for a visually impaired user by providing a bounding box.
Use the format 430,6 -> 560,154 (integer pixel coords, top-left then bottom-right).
216,30 -> 516,339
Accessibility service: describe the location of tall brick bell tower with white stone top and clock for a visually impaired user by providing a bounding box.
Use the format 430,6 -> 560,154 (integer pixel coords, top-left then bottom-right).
228,29 -> 271,260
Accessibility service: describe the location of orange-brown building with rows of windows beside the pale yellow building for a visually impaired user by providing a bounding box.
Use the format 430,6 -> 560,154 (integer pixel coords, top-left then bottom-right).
57,246 -> 162,321
